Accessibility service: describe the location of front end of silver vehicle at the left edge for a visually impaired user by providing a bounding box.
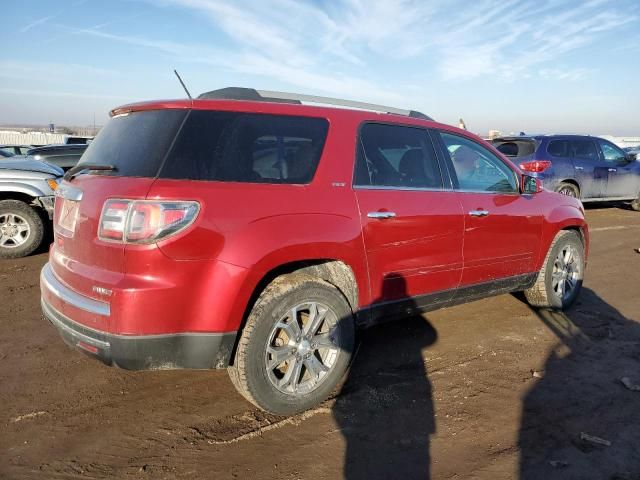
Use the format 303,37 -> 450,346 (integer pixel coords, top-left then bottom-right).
0,156 -> 64,258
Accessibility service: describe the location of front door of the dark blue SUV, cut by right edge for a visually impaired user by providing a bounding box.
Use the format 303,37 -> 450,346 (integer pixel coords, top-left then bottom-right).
598,138 -> 640,199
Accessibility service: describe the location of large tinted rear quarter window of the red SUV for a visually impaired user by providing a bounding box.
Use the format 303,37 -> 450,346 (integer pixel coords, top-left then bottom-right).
159,110 -> 329,184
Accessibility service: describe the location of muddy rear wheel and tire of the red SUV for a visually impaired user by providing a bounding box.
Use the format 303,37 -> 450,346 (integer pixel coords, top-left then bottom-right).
228,273 -> 355,415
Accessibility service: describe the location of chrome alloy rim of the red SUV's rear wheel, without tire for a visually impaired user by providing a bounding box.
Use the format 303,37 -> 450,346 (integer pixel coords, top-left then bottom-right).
265,302 -> 340,395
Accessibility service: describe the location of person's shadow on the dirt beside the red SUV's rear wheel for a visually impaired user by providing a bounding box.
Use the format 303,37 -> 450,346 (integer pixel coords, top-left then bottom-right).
333,275 -> 437,480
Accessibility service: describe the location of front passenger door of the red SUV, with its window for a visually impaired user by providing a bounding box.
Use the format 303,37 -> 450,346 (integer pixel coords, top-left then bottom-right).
439,131 -> 542,287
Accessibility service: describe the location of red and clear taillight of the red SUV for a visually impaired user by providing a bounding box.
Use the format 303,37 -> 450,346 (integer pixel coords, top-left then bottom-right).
98,199 -> 200,243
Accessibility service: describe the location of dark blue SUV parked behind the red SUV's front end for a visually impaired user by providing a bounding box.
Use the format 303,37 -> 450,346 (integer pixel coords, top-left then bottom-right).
492,135 -> 640,211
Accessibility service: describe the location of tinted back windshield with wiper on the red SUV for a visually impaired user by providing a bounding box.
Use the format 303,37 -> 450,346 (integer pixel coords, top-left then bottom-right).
79,110 -> 188,177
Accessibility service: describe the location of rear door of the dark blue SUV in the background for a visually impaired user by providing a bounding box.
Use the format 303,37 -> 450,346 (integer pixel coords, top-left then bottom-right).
571,138 -> 611,200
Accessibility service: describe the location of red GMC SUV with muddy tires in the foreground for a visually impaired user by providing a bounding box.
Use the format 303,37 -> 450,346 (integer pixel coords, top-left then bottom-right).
41,89 -> 588,415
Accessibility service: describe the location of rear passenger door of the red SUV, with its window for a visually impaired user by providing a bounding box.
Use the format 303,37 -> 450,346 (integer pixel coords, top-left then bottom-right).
354,123 -> 463,305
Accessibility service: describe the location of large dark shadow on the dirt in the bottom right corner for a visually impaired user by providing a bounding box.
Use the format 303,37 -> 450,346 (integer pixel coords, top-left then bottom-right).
518,288 -> 640,480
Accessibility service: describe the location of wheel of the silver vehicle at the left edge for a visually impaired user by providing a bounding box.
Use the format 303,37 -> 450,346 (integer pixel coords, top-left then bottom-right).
0,200 -> 44,258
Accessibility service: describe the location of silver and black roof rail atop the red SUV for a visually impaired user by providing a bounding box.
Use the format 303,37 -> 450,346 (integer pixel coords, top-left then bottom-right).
198,87 -> 433,120
